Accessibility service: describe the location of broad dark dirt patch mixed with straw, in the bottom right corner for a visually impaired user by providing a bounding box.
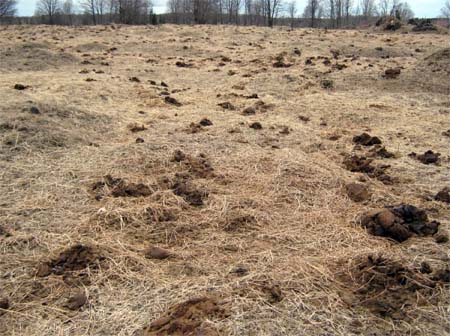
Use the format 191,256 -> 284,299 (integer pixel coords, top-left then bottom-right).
342,255 -> 436,319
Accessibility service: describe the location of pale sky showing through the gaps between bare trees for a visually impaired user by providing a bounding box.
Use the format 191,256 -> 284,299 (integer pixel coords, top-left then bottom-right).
18,0 -> 444,17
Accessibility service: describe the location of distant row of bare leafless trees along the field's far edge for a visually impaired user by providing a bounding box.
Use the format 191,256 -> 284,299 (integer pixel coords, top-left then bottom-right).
0,0 -> 450,28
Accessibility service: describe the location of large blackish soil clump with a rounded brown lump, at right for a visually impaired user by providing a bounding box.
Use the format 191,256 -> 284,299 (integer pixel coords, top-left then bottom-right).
361,205 -> 440,242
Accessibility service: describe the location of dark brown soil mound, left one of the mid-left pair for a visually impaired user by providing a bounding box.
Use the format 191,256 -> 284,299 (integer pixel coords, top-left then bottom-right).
92,175 -> 153,200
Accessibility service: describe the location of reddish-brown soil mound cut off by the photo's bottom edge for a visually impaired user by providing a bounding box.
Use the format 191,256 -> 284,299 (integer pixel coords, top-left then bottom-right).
142,296 -> 230,336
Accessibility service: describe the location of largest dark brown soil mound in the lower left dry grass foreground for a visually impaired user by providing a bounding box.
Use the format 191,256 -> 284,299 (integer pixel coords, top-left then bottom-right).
36,244 -> 104,277
